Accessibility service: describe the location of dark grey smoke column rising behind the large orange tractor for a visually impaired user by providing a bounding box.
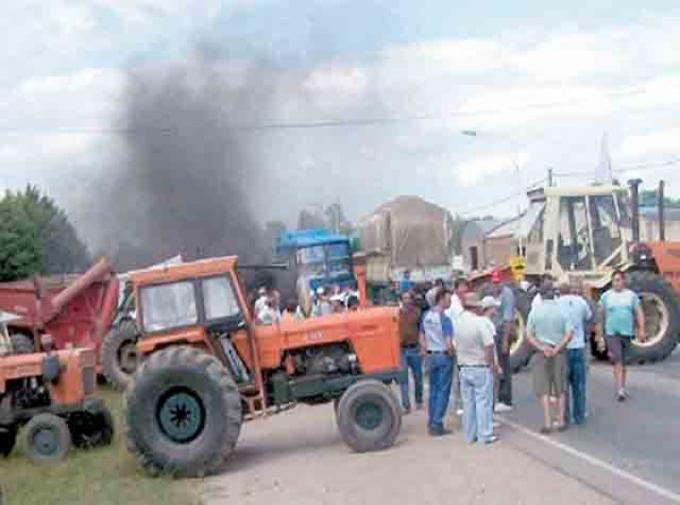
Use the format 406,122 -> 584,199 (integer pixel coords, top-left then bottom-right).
96,61 -> 275,270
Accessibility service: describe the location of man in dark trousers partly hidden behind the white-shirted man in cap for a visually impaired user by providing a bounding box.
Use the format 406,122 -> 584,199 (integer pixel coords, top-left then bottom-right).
491,269 -> 515,412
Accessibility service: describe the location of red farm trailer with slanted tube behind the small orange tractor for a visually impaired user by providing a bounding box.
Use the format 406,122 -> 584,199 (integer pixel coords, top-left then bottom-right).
0,259 -> 119,371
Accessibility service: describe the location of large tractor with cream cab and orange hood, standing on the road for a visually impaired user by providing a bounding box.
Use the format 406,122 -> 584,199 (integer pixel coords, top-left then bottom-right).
488,180 -> 680,371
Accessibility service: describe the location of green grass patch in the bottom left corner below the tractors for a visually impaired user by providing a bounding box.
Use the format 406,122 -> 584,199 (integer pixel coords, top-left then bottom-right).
0,388 -> 198,505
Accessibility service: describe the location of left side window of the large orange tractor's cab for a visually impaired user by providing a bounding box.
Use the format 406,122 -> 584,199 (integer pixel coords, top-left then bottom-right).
141,281 -> 198,332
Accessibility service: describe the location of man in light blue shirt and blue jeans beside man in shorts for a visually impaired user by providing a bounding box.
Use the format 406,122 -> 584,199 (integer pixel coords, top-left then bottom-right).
557,283 -> 593,424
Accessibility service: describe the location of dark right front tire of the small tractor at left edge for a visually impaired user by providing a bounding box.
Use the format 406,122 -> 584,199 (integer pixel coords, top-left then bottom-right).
68,398 -> 114,449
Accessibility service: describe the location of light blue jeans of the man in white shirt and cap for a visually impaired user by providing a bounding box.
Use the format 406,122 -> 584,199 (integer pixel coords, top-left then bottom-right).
460,367 -> 494,443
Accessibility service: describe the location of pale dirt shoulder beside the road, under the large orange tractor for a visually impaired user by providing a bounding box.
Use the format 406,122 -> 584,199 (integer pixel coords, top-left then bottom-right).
201,405 -> 612,505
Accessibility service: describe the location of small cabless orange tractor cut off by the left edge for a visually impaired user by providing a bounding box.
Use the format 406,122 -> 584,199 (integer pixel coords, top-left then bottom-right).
0,312 -> 113,461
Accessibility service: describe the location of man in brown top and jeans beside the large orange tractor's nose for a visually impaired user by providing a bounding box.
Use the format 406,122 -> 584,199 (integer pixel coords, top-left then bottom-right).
399,291 -> 423,413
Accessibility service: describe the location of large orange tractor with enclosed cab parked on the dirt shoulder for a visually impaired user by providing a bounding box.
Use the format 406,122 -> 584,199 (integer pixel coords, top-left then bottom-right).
126,257 -> 404,476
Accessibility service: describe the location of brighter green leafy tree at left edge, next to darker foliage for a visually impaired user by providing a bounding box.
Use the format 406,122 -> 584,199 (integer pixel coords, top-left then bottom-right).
0,193 -> 42,282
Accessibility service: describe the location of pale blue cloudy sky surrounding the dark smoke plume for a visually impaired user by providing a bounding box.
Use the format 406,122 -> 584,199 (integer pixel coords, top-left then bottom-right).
0,0 -> 680,251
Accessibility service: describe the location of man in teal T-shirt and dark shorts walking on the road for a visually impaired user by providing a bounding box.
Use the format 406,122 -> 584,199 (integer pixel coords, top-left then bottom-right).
597,270 -> 646,402
